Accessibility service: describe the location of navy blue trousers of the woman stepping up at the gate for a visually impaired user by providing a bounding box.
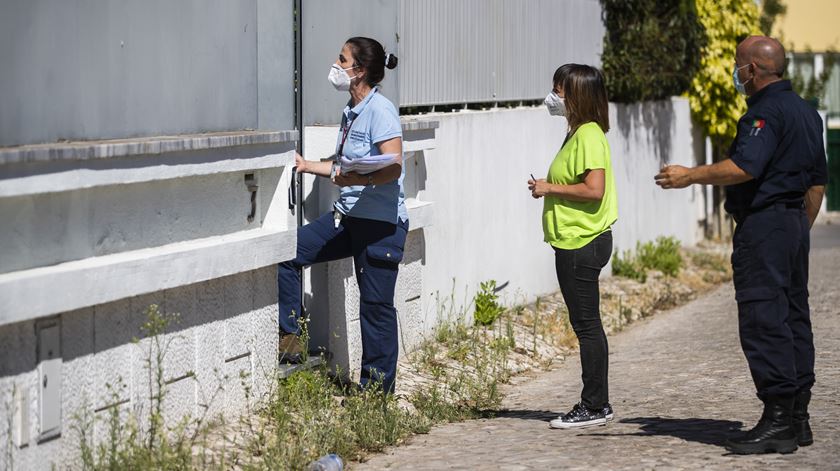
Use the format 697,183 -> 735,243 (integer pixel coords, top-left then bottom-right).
277,213 -> 408,392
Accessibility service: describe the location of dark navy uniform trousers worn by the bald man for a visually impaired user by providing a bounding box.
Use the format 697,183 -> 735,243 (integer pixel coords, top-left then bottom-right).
732,203 -> 814,400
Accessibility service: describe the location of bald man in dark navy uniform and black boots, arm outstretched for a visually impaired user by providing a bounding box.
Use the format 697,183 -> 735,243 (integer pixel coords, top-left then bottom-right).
655,36 -> 827,454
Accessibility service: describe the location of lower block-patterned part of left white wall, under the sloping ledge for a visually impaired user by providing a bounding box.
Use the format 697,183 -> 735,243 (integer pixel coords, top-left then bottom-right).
0,266 -> 278,470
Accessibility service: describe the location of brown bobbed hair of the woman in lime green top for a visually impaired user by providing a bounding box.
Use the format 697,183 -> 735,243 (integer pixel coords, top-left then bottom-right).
563,64 -> 610,134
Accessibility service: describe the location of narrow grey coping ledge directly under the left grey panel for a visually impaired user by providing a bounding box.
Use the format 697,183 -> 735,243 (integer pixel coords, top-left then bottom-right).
0,130 -> 298,165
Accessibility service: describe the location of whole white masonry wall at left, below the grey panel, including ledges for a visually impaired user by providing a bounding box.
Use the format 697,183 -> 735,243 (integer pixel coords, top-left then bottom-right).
0,132 -> 297,469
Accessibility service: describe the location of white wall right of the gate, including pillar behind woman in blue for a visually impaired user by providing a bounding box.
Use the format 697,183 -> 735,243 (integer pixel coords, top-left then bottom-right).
305,98 -> 705,380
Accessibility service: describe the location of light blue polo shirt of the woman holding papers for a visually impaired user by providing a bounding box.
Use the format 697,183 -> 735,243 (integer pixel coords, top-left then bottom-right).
335,87 -> 408,224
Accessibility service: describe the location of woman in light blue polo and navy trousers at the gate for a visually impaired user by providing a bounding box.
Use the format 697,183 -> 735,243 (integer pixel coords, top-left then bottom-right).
278,37 -> 408,392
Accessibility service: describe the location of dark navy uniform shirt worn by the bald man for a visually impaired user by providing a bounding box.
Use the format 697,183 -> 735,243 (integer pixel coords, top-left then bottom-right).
725,80 -> 828,214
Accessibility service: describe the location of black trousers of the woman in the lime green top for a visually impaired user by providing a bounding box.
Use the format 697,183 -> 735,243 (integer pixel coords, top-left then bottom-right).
554,231 -> 612,409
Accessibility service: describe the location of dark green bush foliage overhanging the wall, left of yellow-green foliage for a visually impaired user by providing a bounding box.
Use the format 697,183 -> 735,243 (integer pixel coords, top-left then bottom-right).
601,0 -> 704,102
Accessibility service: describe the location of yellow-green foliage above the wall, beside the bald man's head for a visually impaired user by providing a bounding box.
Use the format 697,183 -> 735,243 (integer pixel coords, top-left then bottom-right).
688,0 -> 761,148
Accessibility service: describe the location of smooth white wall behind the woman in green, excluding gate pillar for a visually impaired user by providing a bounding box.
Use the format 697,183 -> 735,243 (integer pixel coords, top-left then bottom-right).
421,99 -> 702,315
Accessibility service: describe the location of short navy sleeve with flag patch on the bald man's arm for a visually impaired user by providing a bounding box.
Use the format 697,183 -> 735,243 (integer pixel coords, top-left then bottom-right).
729,112 -> 781,178
